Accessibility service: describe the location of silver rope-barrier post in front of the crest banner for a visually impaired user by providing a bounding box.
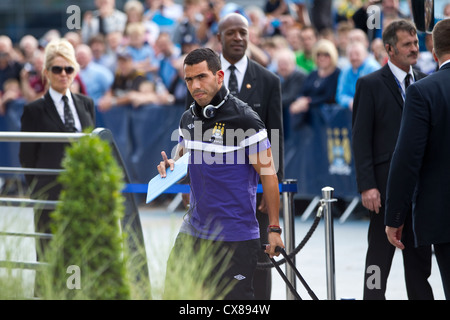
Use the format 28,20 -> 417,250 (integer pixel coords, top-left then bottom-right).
322,187 -> 337,300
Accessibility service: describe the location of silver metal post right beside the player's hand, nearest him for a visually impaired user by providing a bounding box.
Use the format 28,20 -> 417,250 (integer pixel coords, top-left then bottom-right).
282,179 -> 297,300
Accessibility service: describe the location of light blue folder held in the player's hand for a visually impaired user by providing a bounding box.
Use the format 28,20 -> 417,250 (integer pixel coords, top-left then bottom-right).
146,152 -> 189,203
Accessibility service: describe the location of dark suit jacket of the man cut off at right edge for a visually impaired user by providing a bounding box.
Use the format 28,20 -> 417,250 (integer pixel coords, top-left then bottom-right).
386,64 -> 450,245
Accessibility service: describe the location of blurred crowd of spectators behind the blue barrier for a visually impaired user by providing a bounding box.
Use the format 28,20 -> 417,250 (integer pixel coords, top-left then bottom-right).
0,0 -> 450,192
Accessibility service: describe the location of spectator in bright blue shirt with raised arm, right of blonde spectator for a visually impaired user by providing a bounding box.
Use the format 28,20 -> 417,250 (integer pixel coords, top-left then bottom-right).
336,42 -> 381,110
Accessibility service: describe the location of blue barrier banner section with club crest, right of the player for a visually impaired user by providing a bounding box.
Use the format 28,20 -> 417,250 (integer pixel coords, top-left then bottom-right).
284,105 -> 358,198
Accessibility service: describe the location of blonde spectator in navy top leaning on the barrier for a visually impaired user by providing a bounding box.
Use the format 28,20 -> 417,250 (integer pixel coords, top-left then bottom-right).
289,39 -> 340,114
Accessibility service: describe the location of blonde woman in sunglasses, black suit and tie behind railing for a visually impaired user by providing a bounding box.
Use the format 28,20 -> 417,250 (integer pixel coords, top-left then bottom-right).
19,39 -> 95,288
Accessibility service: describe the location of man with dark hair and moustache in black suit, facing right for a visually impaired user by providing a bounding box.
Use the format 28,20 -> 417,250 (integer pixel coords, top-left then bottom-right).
352,20 -> 433,300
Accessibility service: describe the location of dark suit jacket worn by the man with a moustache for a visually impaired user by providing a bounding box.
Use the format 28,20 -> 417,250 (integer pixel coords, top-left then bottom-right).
352,64 -> 426,202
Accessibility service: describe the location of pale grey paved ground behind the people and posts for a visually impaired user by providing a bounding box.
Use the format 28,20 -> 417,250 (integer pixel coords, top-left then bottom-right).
0,202 -> 444,300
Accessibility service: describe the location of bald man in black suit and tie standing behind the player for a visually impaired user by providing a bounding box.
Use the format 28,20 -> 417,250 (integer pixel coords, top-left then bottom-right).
217,13 -> 284,300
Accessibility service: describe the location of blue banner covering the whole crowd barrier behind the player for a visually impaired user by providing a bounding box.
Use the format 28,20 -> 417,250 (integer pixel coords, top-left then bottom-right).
0,100 -> 359,198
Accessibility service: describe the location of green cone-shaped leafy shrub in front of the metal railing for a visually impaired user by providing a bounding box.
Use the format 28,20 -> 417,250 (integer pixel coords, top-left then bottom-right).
38,135 -> 130,299
